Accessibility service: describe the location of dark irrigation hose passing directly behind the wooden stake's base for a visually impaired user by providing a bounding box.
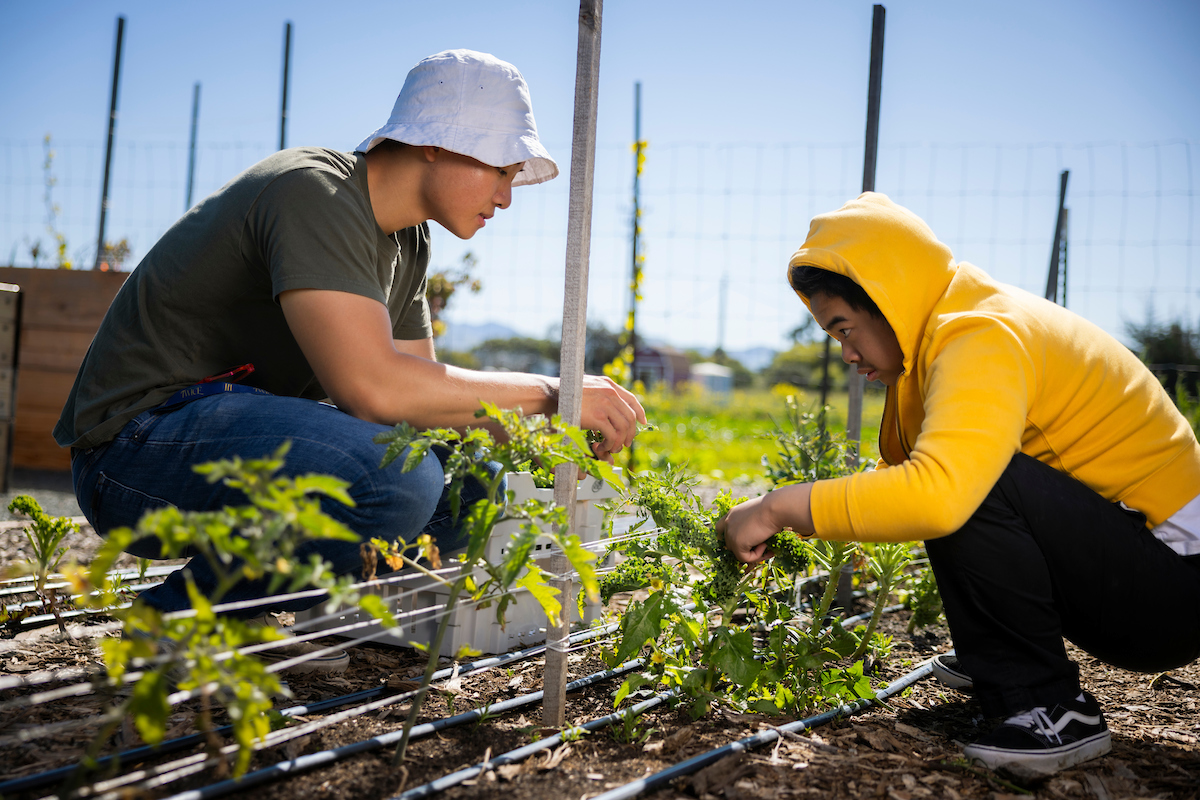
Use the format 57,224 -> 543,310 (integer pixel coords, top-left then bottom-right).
159,658 -> 642,800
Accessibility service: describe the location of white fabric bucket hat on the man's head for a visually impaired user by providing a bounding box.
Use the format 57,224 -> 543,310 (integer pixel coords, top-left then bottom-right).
358,50 -> 558,186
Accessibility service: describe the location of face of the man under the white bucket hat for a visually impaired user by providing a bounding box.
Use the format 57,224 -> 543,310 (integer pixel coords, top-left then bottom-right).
426,149 -> 522,239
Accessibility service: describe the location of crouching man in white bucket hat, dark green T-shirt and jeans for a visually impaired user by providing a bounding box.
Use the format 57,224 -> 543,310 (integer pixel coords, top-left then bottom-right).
54,50 -> 644,669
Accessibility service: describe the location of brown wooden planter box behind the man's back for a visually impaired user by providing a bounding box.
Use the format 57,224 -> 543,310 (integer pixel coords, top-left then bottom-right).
0,266 -> 130,470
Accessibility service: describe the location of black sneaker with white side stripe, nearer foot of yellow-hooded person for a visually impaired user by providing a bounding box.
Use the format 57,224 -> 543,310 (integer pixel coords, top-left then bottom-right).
962,692 -> 1112,777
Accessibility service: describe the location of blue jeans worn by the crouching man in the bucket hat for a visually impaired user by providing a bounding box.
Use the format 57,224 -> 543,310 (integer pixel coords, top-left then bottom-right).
71,393 -> 503,616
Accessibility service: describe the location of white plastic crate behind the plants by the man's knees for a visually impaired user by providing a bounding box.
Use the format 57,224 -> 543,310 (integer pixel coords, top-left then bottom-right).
295,473 -> 617,656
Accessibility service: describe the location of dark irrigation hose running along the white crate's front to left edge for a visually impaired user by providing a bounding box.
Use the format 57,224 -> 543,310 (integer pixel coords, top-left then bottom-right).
0,625 -> 616,798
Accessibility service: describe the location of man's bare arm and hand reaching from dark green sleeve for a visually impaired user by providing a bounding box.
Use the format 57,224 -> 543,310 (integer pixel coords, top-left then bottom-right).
280,289 -> 646,457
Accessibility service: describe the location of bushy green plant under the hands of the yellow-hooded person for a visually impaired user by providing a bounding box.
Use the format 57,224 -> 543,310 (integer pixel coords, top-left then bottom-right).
601,397 -> 907,716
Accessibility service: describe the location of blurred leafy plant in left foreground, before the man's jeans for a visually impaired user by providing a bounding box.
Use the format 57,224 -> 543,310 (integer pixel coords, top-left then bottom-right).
70,444 -> 358,775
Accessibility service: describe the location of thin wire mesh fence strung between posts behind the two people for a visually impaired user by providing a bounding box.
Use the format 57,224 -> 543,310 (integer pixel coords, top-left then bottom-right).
0,139 -> 1200,350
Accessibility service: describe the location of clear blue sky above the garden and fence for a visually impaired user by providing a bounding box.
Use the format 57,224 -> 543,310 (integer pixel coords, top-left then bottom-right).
0,0 -> 1200,349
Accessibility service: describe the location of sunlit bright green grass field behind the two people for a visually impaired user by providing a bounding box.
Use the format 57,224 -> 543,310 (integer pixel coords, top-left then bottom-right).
634,385 -> 883,485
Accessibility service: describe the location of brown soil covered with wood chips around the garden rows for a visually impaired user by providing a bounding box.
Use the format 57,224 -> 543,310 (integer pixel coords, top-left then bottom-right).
0,513 -> 1200,800
